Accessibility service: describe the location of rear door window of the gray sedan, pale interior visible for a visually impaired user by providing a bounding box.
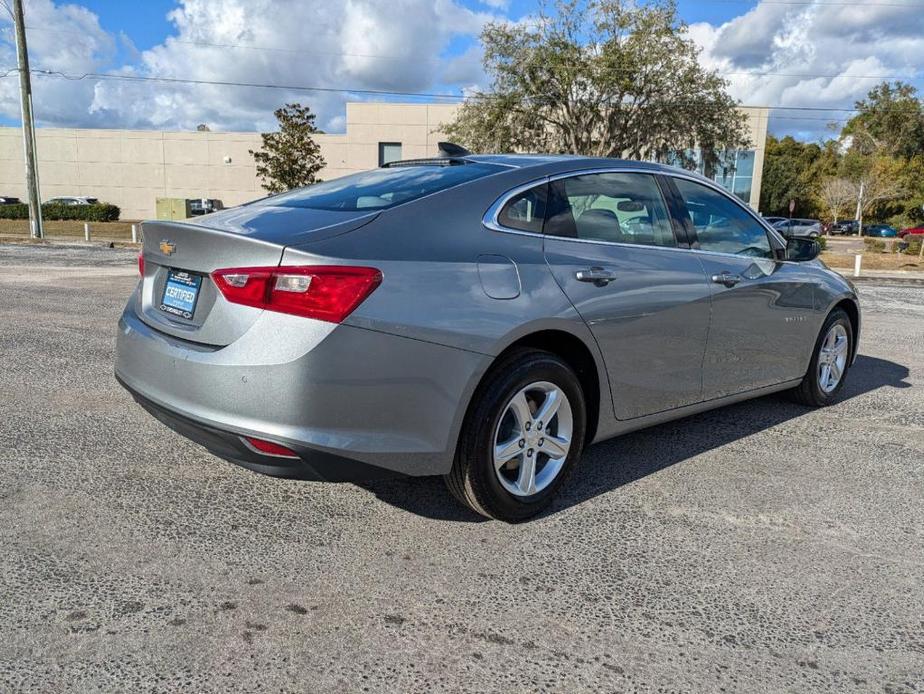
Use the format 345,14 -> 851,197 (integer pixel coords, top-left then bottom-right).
545,173 -> 677,246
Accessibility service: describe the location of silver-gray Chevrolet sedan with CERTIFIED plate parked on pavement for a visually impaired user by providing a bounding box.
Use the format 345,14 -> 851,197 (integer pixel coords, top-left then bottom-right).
115,154 -> 860,522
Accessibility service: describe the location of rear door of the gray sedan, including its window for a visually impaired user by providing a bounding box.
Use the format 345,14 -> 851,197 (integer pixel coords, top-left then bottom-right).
543,172 -> 711,419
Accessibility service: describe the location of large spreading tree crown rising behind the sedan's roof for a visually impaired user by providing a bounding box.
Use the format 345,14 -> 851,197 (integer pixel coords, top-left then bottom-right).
443,0 -> 748,175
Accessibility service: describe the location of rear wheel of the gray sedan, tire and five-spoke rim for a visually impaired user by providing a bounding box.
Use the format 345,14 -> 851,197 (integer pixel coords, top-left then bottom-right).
444,349 -> 587,523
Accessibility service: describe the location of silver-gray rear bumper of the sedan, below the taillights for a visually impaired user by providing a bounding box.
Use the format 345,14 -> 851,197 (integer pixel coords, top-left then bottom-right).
115,301 -> 490,480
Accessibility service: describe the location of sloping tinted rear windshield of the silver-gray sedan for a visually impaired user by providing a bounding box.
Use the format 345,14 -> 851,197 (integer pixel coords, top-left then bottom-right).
267,164 -> 505,210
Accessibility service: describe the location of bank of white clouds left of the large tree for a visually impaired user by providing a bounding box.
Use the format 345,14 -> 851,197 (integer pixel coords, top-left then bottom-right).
0,0 -> 500,131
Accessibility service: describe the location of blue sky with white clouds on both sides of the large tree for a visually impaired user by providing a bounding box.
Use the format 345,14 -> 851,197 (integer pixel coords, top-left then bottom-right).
0,0 -> 924,139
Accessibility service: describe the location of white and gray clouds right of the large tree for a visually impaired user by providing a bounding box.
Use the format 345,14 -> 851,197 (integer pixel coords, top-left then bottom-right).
689,1 -> 924,136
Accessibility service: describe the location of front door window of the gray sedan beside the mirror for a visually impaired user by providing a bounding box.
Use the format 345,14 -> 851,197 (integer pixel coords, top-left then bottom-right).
673,178 -> 774,258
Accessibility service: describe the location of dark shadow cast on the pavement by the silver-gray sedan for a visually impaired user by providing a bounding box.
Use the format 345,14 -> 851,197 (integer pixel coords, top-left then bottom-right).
360,355 -> 911,523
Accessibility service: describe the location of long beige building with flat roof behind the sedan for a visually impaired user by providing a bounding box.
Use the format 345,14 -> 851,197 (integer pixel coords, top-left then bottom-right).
0,102 -> 767,219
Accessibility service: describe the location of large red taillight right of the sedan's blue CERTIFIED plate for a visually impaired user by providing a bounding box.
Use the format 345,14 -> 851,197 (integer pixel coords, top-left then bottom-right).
212,265 -> 382,323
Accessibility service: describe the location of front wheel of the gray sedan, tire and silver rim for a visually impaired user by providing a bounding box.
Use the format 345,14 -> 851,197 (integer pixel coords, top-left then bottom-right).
790,308 -> 854,407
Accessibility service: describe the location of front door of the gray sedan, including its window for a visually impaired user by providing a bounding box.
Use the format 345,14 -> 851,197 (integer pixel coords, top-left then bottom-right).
669,176 -> 817,399
